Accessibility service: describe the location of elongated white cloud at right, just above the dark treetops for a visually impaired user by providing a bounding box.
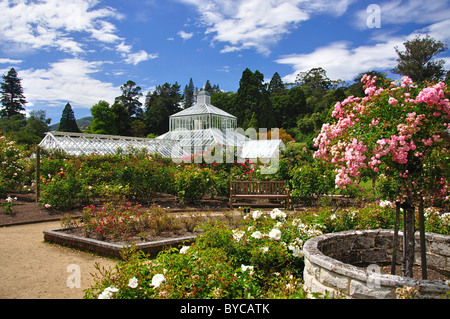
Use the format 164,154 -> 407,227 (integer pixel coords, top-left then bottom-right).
276,38 -> 405,83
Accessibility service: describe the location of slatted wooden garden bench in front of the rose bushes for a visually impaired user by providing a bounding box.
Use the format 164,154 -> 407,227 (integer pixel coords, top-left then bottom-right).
230,181 -> 289,209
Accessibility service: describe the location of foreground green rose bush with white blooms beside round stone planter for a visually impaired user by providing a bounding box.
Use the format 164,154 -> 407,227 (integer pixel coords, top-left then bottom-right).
85,210 -> 321,299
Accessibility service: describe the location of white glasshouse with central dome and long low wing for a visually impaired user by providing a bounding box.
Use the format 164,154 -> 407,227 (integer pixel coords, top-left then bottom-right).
39,91 -> 285,160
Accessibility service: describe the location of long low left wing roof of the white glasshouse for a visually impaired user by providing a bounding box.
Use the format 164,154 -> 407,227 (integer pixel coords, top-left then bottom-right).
39,132 -> 187,158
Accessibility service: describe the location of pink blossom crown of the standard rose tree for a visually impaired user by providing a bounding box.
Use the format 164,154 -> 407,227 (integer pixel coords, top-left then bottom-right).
314,75 -> 450,192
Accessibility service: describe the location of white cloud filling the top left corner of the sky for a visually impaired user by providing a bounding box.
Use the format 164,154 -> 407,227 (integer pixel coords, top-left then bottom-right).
0,0 -> 122,55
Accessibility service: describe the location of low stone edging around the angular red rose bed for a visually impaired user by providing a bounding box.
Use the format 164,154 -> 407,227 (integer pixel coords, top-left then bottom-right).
44,228 -> 197,258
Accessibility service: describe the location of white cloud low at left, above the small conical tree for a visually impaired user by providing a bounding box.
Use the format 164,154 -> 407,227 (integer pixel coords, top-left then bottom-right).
20,58 -> 120,108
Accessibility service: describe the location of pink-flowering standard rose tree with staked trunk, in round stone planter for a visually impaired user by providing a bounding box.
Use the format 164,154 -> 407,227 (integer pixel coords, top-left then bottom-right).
314,75 -> 450,277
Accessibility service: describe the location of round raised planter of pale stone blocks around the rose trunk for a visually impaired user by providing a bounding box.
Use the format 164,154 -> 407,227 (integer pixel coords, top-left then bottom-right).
303,230 -> 450,299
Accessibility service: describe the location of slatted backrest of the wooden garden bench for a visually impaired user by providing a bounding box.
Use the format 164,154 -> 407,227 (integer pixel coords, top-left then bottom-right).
230,181 -> 286,195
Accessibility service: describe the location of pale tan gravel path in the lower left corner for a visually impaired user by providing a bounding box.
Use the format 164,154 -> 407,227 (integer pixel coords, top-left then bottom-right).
0,221 -> 116,299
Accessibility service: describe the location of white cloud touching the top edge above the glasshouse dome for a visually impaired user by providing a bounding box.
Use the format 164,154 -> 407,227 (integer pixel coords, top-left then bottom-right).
180,0 -> 354,55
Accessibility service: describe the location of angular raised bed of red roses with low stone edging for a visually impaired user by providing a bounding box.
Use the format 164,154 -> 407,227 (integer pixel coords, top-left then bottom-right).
44,203 -> 233,258
